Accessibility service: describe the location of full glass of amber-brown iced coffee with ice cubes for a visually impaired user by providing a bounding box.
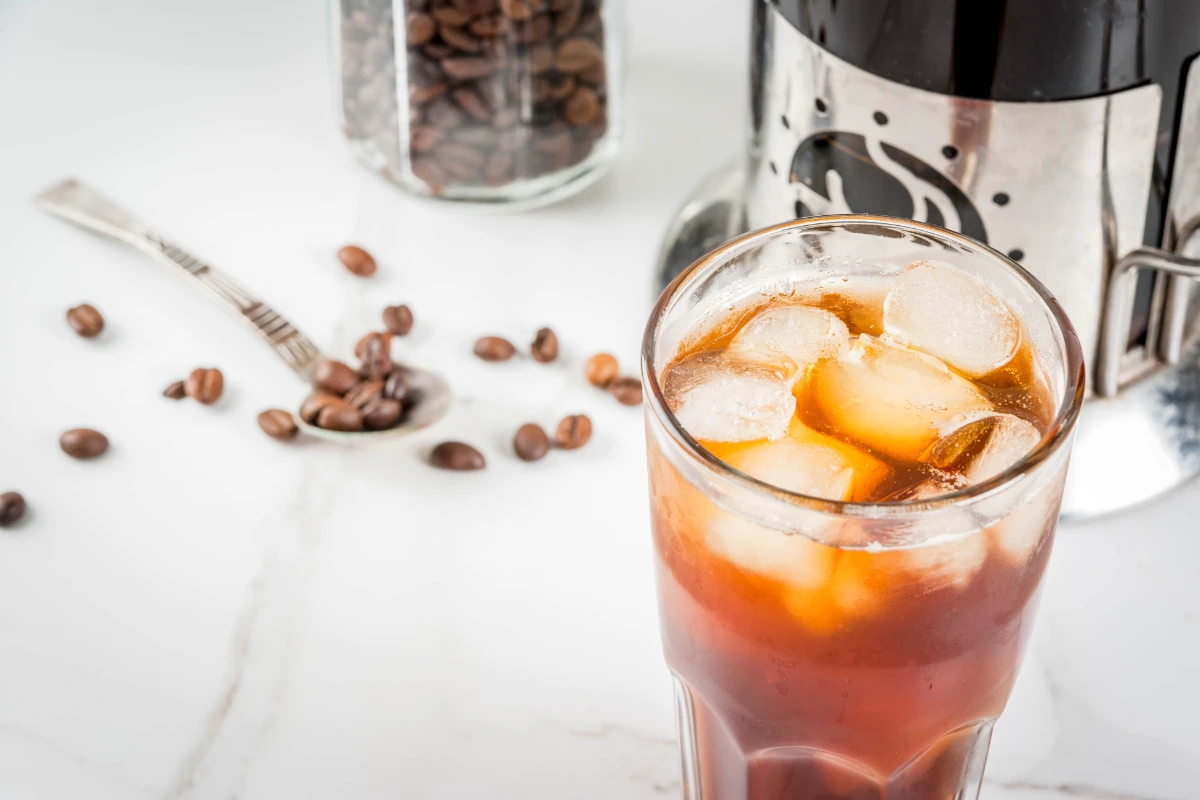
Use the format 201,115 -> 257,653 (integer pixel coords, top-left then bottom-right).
642,216 -> 1084,800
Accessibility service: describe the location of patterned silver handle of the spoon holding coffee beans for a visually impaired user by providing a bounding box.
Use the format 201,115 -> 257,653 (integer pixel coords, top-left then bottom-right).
35,178 -> 322,381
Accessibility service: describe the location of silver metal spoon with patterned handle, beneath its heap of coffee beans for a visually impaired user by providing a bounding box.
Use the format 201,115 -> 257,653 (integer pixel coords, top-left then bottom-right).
35,178 -> 450,441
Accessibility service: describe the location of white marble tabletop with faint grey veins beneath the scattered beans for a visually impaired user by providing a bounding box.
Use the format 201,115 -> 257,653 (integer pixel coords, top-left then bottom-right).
0,0 -> 1200,800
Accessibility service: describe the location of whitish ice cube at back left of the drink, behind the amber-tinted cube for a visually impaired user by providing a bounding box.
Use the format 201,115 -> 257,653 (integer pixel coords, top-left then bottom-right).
730,306 -> 850,377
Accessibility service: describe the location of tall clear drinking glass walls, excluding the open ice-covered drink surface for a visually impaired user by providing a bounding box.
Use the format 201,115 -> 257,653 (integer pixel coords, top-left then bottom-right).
642,216 -> 1084,800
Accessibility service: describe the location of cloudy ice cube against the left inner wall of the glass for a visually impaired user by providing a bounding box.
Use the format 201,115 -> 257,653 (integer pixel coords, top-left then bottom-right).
662,351 -> 796,441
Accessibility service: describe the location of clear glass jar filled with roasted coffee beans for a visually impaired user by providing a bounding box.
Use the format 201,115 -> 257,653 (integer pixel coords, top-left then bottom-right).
332,0 -> 620,206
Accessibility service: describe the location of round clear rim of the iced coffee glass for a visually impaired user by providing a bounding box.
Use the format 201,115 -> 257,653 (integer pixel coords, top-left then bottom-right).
641,213 -> 1085,517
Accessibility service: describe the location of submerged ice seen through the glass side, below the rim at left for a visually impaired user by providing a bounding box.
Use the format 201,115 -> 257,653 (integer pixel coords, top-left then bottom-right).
704,510 -> 838,589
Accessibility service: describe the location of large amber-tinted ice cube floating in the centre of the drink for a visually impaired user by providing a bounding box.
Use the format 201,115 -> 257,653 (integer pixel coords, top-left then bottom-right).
804,333 -> 991,461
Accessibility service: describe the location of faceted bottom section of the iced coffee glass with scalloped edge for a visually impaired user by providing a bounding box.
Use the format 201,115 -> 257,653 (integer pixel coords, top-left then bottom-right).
672,673 -> 996,800
